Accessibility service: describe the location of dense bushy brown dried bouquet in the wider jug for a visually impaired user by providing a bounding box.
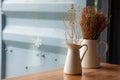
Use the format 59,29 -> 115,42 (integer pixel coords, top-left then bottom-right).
80,6 -> 109,40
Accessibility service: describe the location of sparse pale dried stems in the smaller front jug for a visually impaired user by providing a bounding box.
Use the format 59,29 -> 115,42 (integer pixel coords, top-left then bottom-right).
62,4 -> 80,43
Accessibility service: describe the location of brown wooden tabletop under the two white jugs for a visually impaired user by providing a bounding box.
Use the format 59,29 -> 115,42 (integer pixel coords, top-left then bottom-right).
4,63 -> 120,80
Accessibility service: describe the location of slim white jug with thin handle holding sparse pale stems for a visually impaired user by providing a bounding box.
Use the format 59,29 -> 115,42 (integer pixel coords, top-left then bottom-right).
64,43 -> 87,74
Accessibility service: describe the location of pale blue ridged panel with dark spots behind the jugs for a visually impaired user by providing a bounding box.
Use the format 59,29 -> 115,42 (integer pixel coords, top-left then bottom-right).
2,0 -> 86,78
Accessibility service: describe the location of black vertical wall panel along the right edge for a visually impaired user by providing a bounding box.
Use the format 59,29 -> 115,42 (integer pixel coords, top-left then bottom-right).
108,0 -> 120,64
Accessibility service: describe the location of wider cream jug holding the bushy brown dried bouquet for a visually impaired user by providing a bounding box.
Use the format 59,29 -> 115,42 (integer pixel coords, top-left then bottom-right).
80,39 -> 108,68
